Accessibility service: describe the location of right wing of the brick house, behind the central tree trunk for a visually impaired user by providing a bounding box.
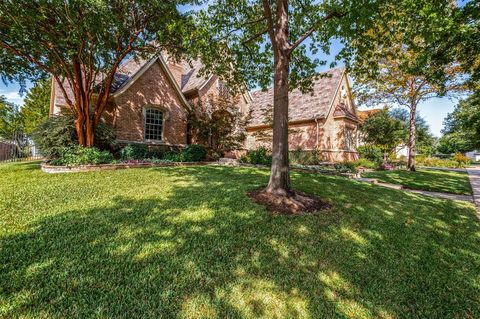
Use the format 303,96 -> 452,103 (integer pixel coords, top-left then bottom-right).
246,68 -> 359,161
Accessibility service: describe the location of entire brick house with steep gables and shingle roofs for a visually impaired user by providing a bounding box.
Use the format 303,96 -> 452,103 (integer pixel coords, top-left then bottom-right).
50,56 -> 358,161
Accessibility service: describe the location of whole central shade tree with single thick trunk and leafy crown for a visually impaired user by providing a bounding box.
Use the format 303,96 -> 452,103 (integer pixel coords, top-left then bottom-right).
189,0 -> 456,195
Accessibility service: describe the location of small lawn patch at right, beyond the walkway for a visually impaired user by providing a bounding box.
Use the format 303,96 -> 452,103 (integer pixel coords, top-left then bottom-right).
362,169 -> 472,195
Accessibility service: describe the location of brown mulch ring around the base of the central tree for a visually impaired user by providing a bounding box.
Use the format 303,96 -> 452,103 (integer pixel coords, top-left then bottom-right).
247,188 -> 332,215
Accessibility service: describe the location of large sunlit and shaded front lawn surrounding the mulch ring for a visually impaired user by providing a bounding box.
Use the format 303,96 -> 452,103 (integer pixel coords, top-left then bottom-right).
0,163 -> 480,318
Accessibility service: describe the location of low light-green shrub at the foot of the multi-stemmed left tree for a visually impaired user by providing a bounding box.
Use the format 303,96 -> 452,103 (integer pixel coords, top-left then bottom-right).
52,145 -> 114,166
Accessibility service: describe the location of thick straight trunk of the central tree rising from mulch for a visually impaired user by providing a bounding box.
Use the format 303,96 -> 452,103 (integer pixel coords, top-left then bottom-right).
266,0 -> 291,196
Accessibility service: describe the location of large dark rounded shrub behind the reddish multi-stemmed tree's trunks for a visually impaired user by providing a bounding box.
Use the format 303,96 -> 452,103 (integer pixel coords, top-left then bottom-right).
32,115 -> 116,158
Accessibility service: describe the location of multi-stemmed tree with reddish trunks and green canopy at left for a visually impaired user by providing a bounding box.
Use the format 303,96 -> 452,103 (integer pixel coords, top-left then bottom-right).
0,0 -> 197,146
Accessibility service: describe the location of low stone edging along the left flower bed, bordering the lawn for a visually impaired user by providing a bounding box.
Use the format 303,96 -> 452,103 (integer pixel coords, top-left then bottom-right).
41,162 -> 214,174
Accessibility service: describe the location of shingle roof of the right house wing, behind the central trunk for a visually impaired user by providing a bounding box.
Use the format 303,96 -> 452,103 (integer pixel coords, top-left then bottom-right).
249,68 -> 345,127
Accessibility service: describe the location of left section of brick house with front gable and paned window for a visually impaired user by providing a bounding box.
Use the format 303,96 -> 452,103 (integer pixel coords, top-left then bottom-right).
50,56 -> 251,147
